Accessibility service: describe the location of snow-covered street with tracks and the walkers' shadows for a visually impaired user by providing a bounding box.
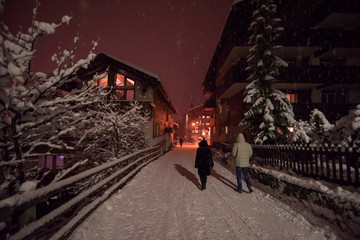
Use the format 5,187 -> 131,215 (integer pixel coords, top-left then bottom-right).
70,145 -> 336,240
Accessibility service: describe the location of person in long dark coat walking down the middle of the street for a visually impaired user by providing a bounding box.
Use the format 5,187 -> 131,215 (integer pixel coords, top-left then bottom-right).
195,139 -> 214,190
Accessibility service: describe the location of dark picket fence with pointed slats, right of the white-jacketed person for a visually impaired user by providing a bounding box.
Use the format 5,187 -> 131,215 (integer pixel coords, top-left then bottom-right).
252,145 -> 360,187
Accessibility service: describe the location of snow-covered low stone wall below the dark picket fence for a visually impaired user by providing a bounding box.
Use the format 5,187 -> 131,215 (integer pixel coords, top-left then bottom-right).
249,165 -> 360,238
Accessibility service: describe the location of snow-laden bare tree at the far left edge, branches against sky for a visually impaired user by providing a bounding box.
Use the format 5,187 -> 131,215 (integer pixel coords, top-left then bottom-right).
0,2 -> 98,183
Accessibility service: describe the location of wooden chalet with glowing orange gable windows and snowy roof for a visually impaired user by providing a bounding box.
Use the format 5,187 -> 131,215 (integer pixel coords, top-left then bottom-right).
77,53 -> 178,151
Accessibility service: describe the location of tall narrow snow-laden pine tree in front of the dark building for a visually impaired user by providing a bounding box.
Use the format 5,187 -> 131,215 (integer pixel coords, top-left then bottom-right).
240,0 -> 295,143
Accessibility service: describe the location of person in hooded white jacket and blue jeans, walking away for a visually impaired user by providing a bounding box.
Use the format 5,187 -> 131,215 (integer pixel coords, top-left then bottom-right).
232,133 -> 253,193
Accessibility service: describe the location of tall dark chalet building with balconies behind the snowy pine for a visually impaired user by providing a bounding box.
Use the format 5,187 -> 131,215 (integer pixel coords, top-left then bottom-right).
203,0 -> 360,143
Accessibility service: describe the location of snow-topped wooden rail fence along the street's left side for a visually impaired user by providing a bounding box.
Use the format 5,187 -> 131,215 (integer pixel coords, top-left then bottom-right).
0,146 -> 161,239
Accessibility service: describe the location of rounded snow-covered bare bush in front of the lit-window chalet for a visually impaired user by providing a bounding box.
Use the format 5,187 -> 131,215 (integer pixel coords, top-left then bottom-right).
72,100 -> 149,162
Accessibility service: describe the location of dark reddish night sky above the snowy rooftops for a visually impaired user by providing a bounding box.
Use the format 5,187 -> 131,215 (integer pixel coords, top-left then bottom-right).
1,0 -> 233,119
